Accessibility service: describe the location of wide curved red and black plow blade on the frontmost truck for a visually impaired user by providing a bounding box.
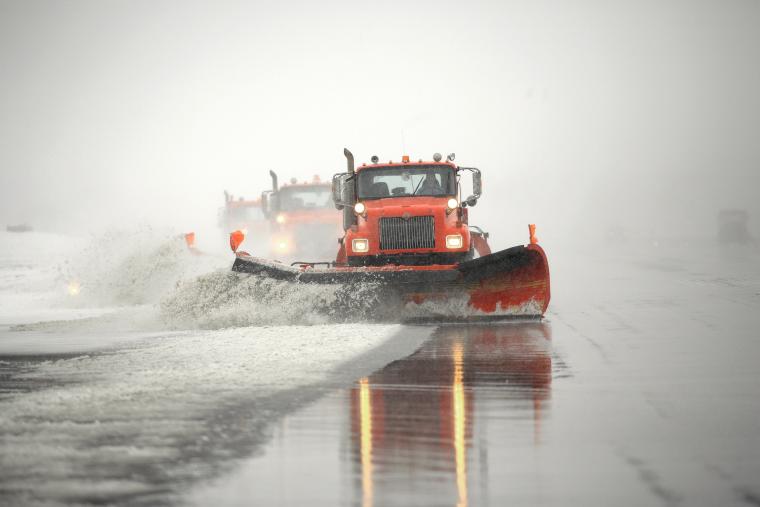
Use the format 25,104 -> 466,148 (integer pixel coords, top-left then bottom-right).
232,244 -> 550,320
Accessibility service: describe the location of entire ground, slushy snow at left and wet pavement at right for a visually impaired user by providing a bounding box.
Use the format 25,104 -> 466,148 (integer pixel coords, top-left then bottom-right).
0,232 -> 760,506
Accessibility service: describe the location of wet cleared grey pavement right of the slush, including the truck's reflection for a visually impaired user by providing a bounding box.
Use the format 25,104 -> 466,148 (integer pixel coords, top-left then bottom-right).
187,245 -> 760,506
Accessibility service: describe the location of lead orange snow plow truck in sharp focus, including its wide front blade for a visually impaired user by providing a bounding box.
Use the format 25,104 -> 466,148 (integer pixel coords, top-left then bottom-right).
230,150 -> 550,319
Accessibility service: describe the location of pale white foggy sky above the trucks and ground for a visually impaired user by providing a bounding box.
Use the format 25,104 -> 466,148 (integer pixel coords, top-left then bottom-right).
0,0 -> 760,246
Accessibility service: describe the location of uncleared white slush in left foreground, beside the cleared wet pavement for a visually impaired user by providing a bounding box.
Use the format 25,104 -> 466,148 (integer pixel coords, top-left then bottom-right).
0,325 -> 399,504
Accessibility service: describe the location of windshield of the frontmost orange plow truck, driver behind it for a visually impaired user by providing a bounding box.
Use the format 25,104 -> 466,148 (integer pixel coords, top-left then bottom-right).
358,165 -> 456,199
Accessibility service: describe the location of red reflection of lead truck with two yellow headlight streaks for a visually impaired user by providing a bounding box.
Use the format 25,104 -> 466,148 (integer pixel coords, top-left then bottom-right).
350,323 -> 551,506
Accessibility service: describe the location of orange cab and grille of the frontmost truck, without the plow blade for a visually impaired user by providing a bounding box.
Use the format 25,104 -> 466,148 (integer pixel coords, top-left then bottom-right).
333,150 -> 482,266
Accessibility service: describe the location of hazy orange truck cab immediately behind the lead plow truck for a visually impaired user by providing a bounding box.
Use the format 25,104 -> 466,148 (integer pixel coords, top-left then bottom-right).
262,171 -> 341,261
